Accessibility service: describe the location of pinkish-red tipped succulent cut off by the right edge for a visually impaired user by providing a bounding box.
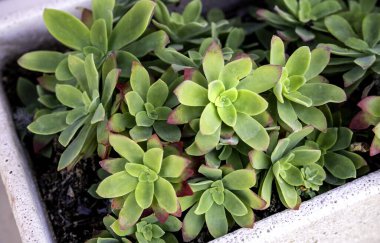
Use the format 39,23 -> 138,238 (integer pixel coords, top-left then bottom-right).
350,96 -> 380,156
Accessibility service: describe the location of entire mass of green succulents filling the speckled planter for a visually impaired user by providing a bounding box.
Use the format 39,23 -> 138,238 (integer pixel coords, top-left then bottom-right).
14,0 -> 380,243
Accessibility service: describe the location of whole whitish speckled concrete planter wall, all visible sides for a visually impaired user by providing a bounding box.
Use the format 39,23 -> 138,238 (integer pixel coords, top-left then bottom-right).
0,0 -> 380,243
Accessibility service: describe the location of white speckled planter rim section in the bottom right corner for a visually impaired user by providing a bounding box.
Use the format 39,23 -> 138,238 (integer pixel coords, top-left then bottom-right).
212,171 -> 380,243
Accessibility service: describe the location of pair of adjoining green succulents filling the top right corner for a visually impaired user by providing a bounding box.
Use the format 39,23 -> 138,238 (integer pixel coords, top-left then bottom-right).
253,0 -> 380,92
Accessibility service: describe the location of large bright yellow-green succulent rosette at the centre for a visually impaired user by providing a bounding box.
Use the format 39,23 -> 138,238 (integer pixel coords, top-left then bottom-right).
168,42 -> 280,155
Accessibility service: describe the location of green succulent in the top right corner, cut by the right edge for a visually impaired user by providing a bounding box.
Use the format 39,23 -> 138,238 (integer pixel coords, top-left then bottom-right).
323,0 -> 380,88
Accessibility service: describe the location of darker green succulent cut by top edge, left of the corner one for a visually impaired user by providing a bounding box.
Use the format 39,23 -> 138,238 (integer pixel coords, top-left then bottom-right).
256,0 -> 344,41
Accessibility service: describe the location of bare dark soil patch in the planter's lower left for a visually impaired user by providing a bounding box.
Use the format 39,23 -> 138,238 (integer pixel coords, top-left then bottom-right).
34,143 -> 108,243
